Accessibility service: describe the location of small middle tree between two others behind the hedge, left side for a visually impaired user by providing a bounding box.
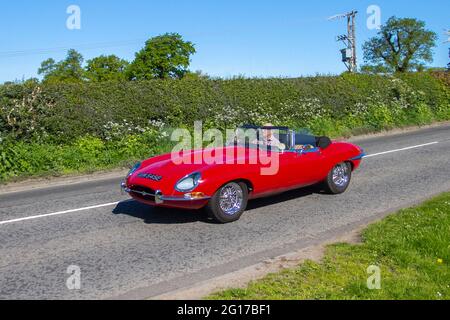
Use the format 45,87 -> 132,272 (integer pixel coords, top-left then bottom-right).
86,55 -> 129,82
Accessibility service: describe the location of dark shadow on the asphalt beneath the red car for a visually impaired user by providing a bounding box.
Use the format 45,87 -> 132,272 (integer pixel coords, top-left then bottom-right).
113,186 -> 324,224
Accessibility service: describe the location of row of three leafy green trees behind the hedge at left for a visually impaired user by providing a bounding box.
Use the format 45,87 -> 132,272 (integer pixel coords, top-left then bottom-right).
33,33 -> 197,84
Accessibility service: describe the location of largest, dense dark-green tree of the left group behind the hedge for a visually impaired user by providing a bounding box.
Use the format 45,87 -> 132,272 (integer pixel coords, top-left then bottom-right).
129,33 -> 195,80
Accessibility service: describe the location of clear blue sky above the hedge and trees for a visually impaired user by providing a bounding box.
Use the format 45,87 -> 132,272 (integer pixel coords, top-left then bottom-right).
0,0 -> 450,82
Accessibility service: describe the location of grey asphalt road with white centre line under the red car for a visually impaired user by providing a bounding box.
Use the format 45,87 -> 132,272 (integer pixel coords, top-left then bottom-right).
0,125 -> 450,299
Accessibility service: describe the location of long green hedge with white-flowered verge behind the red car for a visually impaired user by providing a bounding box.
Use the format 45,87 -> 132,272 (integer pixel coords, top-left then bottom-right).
0,73 -> 450,179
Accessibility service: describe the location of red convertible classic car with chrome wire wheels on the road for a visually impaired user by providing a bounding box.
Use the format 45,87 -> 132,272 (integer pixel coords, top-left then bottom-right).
122,126 -> 364,223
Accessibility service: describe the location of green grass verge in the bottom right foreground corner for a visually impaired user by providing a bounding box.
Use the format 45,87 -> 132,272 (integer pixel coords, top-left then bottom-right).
208,193 -> 450,300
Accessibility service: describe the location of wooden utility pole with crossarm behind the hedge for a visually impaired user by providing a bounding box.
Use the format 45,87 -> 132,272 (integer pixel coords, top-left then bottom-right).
328,10 -> 358,72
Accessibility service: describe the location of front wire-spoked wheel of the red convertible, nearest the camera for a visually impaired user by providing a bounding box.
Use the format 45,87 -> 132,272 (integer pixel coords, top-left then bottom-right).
206,182 -> 248,223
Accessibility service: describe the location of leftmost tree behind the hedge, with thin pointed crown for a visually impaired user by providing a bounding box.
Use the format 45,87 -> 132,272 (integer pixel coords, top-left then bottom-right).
38,49 -> 84,82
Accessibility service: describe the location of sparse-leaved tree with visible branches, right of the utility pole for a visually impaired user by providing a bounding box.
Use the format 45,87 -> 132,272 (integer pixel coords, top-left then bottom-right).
363,17 -> 437,72
